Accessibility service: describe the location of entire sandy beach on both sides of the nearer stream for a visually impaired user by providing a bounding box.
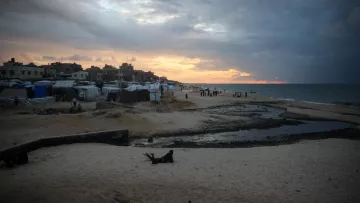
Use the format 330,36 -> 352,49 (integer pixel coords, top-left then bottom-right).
0,91 -> 360,203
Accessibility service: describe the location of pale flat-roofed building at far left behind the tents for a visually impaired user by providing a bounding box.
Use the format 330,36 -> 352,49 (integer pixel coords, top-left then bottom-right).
0,58 -> 44,80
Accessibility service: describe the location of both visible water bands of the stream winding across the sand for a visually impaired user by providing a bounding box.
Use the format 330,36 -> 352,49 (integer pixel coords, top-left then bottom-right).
132,105 -> 353,147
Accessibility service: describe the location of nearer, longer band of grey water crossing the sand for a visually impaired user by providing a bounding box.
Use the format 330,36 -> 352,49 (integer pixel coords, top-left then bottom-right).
132,121 -> 352,147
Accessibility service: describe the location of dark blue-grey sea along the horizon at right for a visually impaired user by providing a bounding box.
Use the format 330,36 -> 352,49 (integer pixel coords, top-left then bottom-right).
189,84 -> 360,107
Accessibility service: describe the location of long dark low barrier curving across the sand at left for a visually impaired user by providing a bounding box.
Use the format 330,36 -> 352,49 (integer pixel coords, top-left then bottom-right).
0,130 -> 129,164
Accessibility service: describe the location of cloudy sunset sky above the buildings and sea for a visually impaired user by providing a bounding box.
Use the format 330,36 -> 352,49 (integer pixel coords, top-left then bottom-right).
0,0 -> 360,84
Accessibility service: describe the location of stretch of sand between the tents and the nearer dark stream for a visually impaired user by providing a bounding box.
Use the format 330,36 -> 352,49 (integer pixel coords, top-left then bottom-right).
0,91 -> 360,149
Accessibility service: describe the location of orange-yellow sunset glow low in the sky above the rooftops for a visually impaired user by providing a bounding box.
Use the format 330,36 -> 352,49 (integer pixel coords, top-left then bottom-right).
0,38 -> 286,84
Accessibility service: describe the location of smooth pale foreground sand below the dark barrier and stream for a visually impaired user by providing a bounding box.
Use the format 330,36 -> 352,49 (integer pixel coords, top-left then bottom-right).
0,139 -> 360,203
